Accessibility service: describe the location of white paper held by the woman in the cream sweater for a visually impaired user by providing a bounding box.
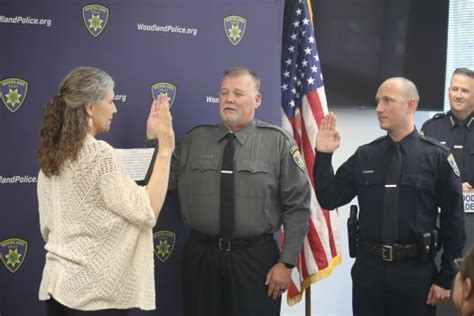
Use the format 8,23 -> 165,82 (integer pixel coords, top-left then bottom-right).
115,148 -> 154,181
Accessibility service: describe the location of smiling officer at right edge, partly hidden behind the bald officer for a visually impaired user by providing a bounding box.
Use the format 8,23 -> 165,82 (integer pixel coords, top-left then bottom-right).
420,68 -> 474,191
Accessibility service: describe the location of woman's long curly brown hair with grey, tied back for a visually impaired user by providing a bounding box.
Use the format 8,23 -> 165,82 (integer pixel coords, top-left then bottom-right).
38,67 -> 115,177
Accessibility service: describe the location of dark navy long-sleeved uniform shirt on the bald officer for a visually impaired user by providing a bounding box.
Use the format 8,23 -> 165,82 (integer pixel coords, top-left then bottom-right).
314,129 -> 465,288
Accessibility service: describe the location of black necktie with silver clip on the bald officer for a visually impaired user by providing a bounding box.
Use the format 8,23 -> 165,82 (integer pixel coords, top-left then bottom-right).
382,143 -> 402,245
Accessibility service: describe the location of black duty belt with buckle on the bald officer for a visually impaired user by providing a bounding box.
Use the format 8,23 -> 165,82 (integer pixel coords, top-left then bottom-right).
357,240 -> 419,261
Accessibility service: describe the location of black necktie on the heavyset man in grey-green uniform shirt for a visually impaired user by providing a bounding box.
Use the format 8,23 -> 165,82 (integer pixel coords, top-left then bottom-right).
220,133 -> 235,240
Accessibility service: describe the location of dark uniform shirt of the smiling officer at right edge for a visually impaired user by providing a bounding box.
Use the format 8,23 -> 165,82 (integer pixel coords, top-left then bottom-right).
421,111 -> 474,185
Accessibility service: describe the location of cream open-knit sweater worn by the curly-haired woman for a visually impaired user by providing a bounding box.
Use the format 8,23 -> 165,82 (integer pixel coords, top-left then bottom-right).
38,135 -> 157,310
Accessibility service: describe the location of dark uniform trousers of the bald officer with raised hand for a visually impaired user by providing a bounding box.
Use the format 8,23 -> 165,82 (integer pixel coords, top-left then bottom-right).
351,256 -> 437,316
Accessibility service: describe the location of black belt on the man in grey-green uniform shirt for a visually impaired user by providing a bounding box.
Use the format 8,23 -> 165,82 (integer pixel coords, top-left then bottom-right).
189,230 -> 273,251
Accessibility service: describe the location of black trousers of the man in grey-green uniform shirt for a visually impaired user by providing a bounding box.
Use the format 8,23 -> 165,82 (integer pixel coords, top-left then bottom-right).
182,236 -> 281,316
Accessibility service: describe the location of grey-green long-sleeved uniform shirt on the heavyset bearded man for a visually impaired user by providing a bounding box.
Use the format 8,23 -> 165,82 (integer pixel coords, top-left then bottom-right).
169,120 -> 311,265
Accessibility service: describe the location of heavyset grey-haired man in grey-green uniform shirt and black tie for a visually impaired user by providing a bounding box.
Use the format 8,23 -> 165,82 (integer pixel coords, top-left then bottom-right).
147,67 -> 310,316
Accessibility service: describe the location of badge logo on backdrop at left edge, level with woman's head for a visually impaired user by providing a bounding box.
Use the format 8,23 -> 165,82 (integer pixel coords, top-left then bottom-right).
0,78 -> 28,113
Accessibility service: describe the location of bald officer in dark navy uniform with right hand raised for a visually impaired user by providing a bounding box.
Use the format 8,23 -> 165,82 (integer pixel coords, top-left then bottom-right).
314,77 -> 465,316
